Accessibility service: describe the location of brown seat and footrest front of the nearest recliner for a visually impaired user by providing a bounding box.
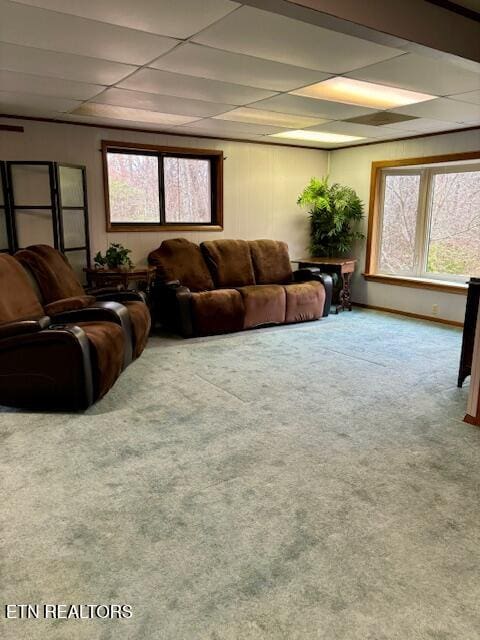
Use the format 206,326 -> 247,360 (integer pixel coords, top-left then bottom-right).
75,322 -> 125,400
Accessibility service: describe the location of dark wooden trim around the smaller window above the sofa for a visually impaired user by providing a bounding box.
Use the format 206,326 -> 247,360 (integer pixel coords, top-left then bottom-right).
101,140 -> 224,233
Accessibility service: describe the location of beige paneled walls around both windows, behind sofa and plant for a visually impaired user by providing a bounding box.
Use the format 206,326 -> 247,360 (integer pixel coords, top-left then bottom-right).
0,119 -> 480,321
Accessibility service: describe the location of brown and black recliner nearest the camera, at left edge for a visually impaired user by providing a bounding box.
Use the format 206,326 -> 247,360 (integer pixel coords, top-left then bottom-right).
0,254 -> 125,410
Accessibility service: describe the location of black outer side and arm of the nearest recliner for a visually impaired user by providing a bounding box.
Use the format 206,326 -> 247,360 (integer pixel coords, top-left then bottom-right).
0,318 -> 96,411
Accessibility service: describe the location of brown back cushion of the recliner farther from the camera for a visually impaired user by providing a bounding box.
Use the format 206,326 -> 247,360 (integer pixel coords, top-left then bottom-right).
15,244 -> 85,304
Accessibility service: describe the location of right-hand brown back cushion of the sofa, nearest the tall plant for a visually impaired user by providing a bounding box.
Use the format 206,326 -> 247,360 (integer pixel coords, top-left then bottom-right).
248,240 -> 293,284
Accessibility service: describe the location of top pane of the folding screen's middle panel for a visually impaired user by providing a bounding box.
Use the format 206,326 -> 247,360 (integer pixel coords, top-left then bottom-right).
12,164 -> 52,207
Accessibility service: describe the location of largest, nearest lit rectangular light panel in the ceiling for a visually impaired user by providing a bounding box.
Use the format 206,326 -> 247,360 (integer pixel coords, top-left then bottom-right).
290,76 -> 437,109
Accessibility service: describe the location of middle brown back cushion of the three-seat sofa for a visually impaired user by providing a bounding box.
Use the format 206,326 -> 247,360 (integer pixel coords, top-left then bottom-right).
200,240 -> 255,288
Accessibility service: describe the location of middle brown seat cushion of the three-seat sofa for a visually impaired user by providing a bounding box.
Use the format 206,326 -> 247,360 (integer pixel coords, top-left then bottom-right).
238,284 -> 286,329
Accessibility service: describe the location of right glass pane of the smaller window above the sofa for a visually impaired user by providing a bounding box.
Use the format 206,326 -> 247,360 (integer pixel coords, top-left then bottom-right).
163,158 -> 212,223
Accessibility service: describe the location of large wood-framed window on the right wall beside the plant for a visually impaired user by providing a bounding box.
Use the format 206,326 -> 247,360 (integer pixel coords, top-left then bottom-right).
365,154 -> 480,292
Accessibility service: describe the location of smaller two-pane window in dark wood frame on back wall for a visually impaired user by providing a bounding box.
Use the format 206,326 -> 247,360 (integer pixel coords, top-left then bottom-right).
102,141 -> 223,231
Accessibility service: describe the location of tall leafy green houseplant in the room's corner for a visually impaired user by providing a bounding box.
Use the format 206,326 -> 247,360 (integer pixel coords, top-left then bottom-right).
297,177 -> 365,258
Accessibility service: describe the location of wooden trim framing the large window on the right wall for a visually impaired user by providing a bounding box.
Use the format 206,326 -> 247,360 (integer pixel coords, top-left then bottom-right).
363,151 -> 480,295
